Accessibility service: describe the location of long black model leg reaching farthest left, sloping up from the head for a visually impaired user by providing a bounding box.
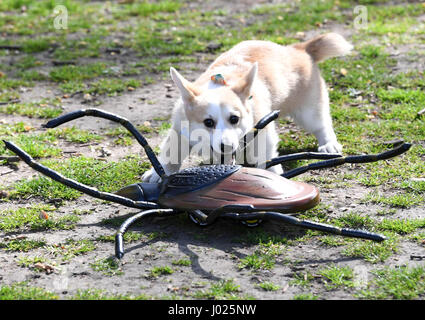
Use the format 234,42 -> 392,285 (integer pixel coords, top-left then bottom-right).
3,140 -> 159,209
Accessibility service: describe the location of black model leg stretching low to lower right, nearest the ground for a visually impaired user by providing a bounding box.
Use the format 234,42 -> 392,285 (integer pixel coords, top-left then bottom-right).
264,212 -> 386,242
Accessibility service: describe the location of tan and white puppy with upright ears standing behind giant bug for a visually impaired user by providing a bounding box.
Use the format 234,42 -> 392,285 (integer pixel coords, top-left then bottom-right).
143,33 -> 352,182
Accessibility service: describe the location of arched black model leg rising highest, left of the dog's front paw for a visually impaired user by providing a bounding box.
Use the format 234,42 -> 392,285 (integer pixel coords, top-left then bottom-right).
44,108 -> 165,177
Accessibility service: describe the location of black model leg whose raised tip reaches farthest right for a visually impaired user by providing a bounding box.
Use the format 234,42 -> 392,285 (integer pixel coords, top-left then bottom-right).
282,143 -> 412,179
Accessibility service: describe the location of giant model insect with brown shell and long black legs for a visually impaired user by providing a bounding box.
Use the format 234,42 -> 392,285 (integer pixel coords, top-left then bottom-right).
4,109 -> 410,258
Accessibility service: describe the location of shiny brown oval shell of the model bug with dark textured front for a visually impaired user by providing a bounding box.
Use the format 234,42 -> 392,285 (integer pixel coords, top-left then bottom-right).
158,165 -> 320,213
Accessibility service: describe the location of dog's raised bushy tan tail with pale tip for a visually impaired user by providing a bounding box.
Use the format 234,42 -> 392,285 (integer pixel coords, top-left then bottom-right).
294,32 -> 353,62
